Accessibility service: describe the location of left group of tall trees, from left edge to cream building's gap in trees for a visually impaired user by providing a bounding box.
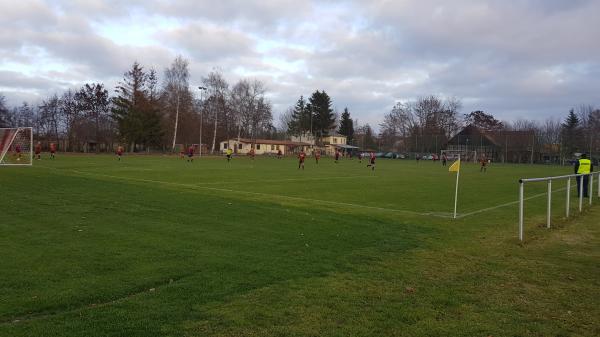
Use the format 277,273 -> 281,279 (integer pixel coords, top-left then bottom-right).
0,56 -> 277,152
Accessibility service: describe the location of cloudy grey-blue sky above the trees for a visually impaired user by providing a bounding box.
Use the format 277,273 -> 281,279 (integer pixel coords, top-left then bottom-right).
0,0 -> 600,125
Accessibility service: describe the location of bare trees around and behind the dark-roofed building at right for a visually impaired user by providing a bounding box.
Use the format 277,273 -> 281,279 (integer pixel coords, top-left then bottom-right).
377,95 -> 600,160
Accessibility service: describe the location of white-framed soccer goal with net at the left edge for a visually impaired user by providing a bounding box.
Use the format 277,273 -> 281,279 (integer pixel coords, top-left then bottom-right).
0,127 -> 33,166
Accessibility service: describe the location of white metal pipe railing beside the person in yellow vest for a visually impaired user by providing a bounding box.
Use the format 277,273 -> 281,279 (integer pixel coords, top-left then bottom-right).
519,172 -> 600,241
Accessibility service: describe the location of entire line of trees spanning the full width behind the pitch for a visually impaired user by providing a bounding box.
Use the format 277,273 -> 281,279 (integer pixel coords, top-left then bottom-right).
0,61 -> 600,158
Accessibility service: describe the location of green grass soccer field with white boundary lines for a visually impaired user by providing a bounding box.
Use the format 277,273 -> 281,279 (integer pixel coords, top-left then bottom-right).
0,155 -> 600,337
